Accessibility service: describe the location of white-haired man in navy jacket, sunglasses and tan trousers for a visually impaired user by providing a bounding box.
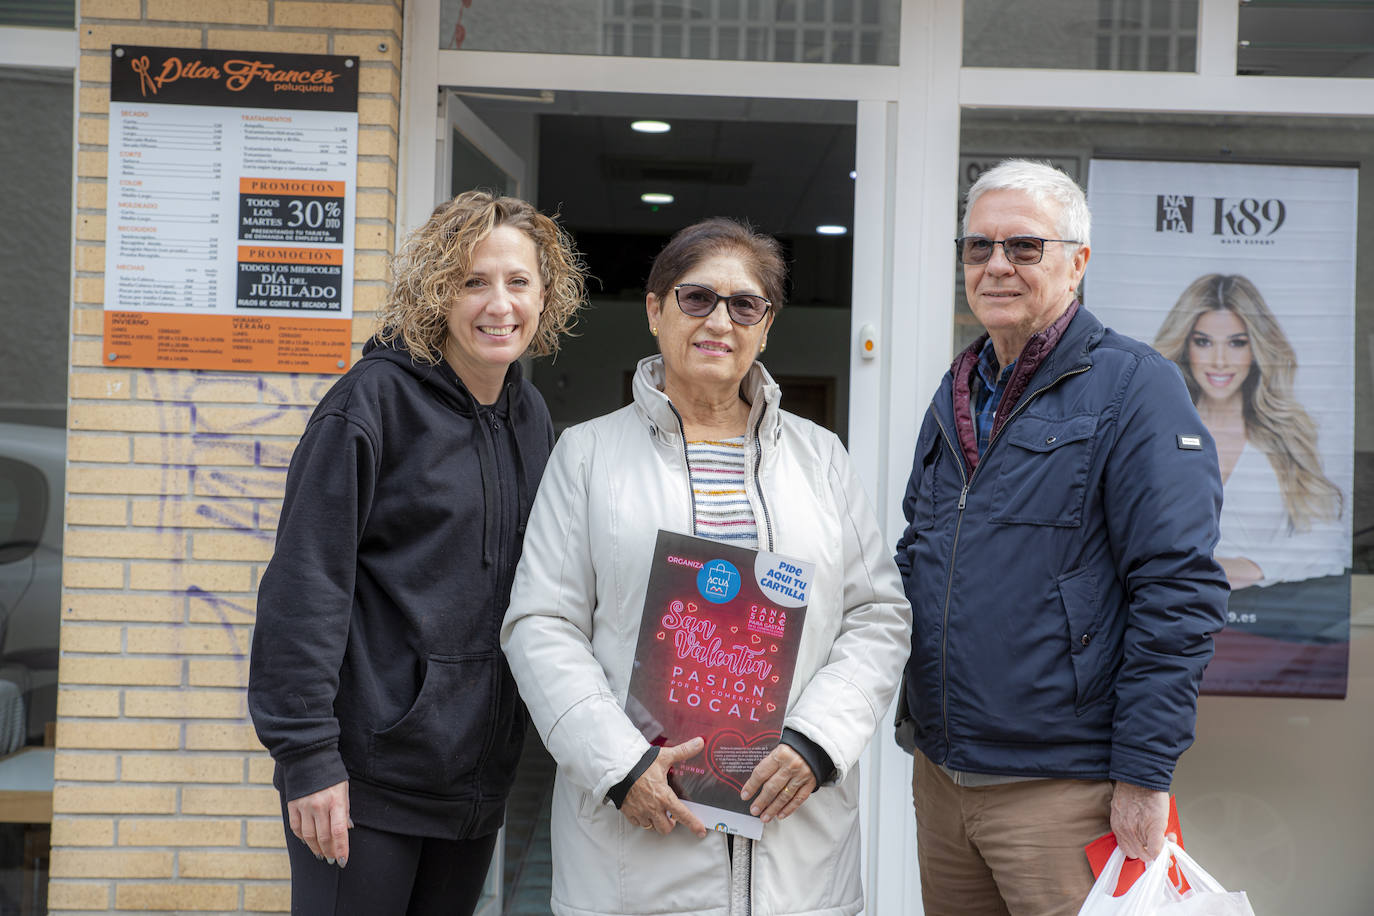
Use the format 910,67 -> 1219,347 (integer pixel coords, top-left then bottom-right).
897,159 -> 1227,916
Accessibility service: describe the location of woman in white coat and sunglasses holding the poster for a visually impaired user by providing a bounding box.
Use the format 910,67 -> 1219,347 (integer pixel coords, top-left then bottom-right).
502,220 -> 911,916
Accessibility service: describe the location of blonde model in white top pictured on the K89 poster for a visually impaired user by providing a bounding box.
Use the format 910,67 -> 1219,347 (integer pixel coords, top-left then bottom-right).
1154,273 -> 1345,589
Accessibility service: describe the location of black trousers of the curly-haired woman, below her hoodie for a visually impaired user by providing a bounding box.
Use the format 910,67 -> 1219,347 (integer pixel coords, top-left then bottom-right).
282,809 -> 499,916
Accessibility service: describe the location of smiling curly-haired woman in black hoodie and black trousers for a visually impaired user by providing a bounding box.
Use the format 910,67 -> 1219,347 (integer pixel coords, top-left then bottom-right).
249,191 -> 584,916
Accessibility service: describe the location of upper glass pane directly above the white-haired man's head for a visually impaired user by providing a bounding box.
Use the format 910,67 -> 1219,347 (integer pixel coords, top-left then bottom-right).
963,0 -> 1198,73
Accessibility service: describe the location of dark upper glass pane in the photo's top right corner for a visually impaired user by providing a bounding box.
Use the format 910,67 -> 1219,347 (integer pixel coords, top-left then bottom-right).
1235,0 -> 1374,77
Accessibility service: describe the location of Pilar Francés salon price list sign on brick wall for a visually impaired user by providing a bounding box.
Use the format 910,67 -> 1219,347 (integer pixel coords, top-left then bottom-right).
103,45 -> 359,374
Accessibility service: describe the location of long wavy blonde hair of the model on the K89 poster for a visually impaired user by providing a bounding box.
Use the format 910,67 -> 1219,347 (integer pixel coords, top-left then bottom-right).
1154,273 -> 1342,531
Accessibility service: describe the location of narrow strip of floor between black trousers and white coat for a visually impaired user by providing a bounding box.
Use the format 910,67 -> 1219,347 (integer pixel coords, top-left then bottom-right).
502,728 -> 555,916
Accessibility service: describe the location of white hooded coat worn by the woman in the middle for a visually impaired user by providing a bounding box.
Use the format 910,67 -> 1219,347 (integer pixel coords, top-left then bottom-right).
502,356 -> 911,916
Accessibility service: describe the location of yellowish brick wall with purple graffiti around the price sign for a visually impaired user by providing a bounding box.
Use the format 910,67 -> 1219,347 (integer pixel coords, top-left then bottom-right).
59,0 -> 401,913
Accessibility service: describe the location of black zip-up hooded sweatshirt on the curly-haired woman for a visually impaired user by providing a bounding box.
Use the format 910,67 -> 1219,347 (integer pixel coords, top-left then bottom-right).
249,341 -> 554,839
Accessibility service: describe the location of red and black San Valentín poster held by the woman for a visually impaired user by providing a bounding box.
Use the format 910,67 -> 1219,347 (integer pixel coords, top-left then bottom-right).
625,530 -> 815,839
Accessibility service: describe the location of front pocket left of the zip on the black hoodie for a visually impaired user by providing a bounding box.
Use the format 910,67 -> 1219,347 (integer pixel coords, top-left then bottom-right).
367,654 -> 499,797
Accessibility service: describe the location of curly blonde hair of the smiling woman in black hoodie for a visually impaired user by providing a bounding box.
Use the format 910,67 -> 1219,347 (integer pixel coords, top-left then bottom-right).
376,191 -> 587,365
